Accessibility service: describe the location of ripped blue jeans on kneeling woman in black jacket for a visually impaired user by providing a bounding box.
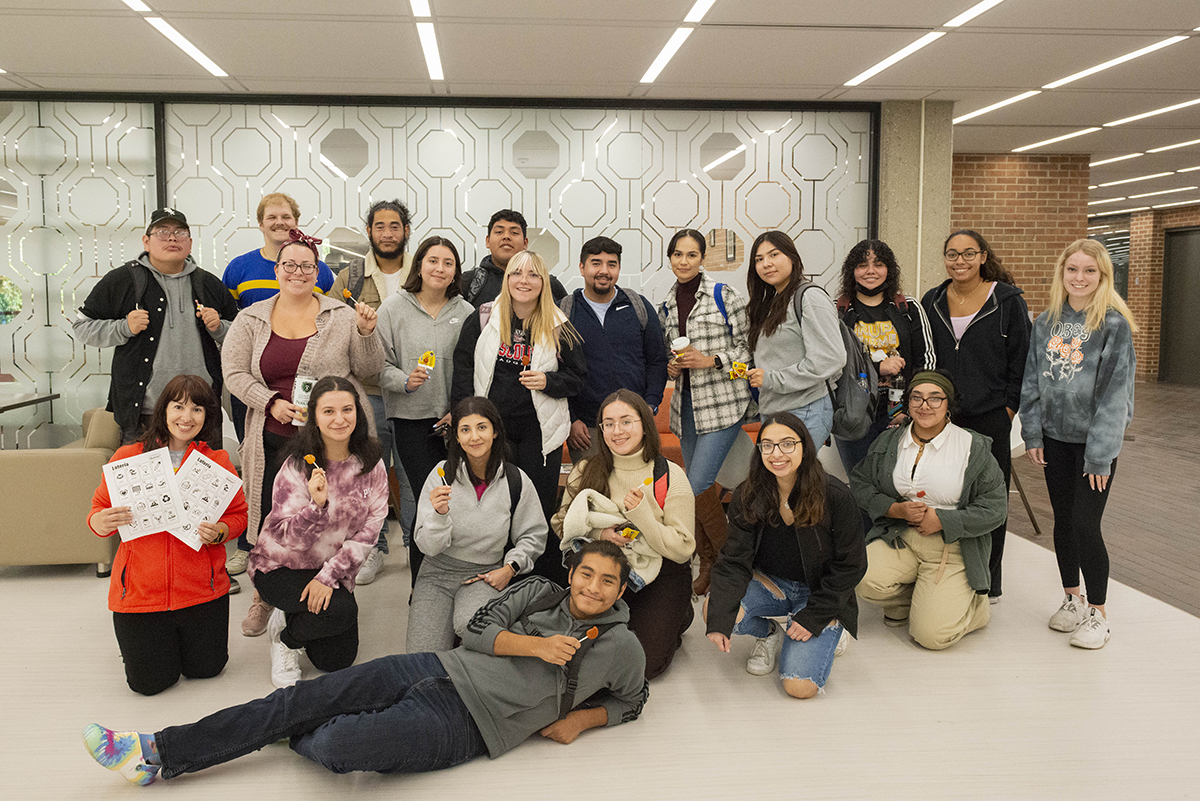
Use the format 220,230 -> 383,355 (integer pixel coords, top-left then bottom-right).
733,573 -> 842,687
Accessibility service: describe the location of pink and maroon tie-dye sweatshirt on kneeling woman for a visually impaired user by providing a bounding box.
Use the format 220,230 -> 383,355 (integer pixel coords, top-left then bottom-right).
247,457 -> 388,592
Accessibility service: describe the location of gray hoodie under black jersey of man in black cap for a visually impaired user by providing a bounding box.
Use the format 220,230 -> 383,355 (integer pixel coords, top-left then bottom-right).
72,253 -> 232,410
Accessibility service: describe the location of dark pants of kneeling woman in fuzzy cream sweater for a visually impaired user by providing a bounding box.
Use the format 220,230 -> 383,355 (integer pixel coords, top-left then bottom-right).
622,559 -> 695,679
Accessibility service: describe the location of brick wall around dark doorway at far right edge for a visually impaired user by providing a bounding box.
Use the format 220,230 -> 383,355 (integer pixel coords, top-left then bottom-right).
1128,205 -> 1200,380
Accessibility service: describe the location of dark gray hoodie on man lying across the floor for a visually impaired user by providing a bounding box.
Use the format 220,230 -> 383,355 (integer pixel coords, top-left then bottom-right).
438,576 -> 649,759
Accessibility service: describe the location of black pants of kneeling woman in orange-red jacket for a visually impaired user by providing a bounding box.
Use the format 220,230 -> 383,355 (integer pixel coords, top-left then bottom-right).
113,595 -> 229,695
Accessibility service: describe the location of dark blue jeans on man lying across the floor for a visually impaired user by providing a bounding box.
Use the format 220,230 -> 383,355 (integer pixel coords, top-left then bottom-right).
155,654 -> 487,778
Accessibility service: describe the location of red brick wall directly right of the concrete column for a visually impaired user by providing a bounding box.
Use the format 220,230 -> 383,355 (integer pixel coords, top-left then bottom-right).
938,153 -> 1094,314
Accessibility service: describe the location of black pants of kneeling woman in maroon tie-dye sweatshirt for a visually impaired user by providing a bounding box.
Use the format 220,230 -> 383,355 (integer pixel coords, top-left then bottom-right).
254,567 -> 359,673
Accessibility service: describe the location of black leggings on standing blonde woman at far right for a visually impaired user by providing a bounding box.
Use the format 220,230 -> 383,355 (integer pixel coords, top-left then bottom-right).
1043,436 -> 1117,607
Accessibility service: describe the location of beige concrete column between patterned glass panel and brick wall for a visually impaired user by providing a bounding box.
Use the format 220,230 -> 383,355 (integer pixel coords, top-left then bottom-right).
880,101 -> 954,299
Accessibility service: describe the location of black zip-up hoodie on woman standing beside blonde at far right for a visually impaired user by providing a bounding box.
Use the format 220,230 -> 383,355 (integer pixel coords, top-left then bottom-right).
920,278 -> 1033,417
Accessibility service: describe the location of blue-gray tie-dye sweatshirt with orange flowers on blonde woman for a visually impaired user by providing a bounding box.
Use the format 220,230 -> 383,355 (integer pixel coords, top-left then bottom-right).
1021,303 -> 1138,476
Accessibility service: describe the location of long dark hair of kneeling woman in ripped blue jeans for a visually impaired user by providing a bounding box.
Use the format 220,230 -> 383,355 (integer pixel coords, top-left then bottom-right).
740,411 -> 826,528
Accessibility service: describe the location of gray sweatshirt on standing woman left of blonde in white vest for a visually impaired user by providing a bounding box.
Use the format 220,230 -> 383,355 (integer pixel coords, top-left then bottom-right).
376,290 -> 475,420
